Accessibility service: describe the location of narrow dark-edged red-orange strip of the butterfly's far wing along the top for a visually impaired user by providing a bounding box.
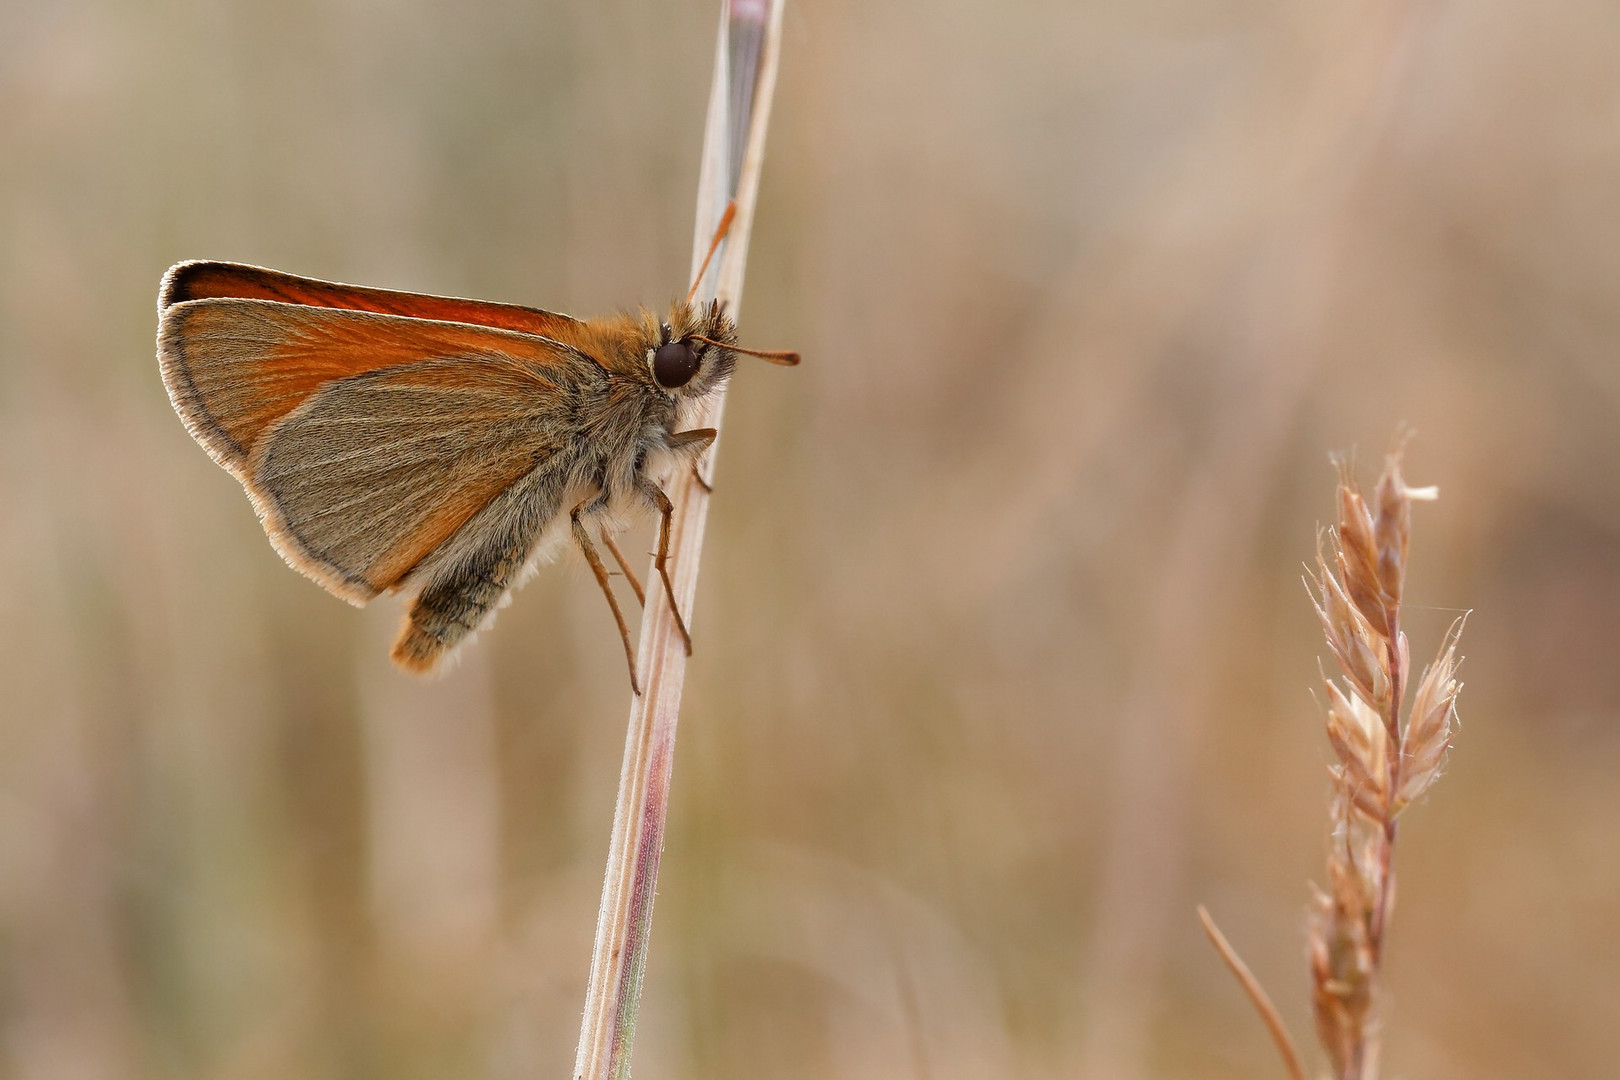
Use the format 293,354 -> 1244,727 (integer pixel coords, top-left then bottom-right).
157,262 -> 580,340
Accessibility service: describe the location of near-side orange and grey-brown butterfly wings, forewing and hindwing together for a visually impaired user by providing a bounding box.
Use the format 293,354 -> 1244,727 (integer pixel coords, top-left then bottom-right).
159,290 -> 606,602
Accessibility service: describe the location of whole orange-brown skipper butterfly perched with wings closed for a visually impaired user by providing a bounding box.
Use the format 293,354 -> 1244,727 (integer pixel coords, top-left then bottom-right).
157,254 -> 797,691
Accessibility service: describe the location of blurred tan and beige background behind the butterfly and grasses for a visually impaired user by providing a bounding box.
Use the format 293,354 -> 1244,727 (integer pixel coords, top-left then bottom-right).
0,0 -> 1620,1080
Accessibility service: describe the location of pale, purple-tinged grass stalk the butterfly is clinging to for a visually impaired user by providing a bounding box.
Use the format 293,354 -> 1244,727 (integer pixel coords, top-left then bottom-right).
573,0 -> 784,1080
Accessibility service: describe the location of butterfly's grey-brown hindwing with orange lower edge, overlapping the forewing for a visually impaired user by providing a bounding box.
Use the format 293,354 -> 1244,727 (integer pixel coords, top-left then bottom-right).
246,356 -> 599,599
